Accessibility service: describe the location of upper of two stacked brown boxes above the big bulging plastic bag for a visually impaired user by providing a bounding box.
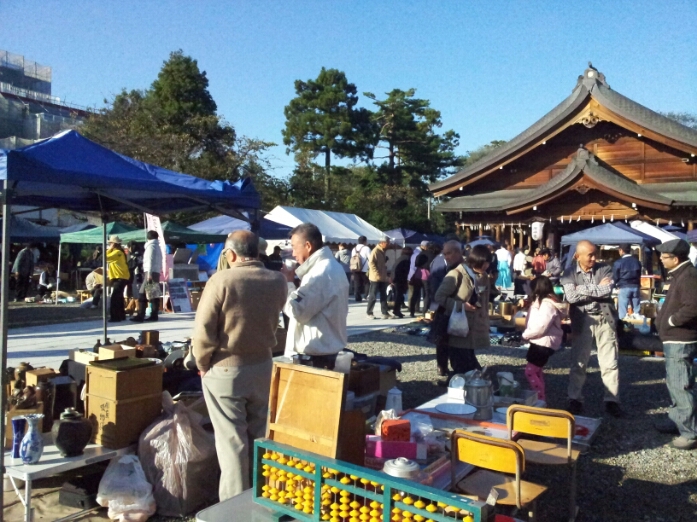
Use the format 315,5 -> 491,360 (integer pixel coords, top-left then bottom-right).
86,364 -> 163,401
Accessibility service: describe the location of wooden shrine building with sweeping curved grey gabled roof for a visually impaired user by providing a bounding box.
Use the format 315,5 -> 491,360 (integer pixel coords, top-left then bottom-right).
430,64 -> 697,246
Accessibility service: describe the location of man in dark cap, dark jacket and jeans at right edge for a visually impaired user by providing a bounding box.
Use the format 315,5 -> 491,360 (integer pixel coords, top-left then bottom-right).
656,239 -> 697,450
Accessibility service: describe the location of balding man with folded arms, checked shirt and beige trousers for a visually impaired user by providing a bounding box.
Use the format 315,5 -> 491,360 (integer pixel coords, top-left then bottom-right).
561,241 -> 622,417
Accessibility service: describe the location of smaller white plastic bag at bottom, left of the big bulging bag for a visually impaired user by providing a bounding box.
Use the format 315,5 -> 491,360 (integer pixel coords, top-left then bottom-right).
97,455 -> 156,522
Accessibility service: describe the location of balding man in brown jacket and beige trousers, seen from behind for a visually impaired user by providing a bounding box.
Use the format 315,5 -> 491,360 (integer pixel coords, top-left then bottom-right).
193,230 -> 288,501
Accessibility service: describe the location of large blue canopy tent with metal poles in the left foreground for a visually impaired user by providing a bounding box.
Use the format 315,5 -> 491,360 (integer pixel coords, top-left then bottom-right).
0,131 -> 260,480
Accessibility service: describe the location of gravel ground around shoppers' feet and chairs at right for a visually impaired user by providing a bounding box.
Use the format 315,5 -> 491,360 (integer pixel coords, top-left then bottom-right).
349,331 -> 697,522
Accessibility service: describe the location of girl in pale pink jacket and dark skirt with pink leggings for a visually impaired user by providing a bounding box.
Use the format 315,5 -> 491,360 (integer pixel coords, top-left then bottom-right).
523,276 -> 564,400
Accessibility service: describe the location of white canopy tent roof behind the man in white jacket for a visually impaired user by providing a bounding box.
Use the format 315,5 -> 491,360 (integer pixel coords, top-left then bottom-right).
266,206 -> 385,245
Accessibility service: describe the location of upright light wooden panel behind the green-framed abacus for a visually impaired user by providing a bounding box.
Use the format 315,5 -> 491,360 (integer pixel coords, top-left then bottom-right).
266,363 -> 345,458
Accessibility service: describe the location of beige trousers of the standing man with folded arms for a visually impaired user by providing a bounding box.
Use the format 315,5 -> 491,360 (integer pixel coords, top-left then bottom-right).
569,314 -> 620,402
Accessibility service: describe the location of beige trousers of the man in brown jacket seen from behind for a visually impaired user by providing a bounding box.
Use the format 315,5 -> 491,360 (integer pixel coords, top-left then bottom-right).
203,359 -> 273,502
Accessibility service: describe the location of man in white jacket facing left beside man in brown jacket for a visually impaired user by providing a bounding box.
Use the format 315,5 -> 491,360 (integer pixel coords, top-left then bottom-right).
281,223 -> 348,369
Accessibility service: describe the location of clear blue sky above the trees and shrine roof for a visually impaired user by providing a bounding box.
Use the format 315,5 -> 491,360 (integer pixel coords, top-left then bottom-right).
0,0 -> 697,175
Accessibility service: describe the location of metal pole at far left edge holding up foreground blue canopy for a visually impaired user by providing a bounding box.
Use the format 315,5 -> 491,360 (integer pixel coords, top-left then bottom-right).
0,180 -> 10,522
